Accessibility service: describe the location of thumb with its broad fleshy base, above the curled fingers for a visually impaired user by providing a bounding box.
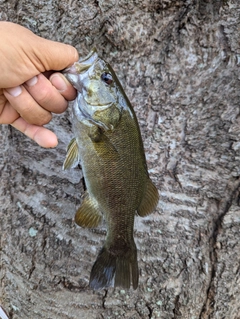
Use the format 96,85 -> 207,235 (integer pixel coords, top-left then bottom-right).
0,21 -> 78,88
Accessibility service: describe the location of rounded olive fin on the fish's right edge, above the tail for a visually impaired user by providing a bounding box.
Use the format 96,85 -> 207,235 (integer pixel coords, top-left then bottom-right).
137,179 -> 159,217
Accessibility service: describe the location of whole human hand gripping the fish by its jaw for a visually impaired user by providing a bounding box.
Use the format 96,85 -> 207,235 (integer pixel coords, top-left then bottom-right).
0,22 -> 78,147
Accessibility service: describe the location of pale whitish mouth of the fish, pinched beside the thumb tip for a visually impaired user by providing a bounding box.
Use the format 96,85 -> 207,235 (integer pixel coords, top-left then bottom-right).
63,48 -> 98,75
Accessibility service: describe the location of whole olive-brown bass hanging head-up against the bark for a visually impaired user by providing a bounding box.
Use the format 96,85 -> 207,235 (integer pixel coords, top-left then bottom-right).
63,49 -> 159,290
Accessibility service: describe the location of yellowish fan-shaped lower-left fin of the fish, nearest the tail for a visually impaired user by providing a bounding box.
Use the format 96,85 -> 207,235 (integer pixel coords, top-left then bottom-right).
75,195 -> 102,228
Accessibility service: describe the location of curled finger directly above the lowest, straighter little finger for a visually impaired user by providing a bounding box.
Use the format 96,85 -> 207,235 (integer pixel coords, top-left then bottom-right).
3,85 -> 52,126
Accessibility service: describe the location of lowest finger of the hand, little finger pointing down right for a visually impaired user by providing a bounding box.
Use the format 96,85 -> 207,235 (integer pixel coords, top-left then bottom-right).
11,117 -> 58,148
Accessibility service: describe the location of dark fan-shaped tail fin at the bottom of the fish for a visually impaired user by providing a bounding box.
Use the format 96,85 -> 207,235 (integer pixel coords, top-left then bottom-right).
89,244 -> 139,289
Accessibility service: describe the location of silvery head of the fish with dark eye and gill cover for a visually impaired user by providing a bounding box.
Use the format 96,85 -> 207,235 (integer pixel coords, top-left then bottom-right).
63,49 -> 127,129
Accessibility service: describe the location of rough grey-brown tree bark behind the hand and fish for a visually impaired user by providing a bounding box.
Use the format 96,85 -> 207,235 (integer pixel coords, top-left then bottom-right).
0,0 -> 240,319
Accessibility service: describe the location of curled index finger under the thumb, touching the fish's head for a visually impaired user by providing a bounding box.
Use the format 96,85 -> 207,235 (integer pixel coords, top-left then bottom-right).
49,72 -> 77,101
